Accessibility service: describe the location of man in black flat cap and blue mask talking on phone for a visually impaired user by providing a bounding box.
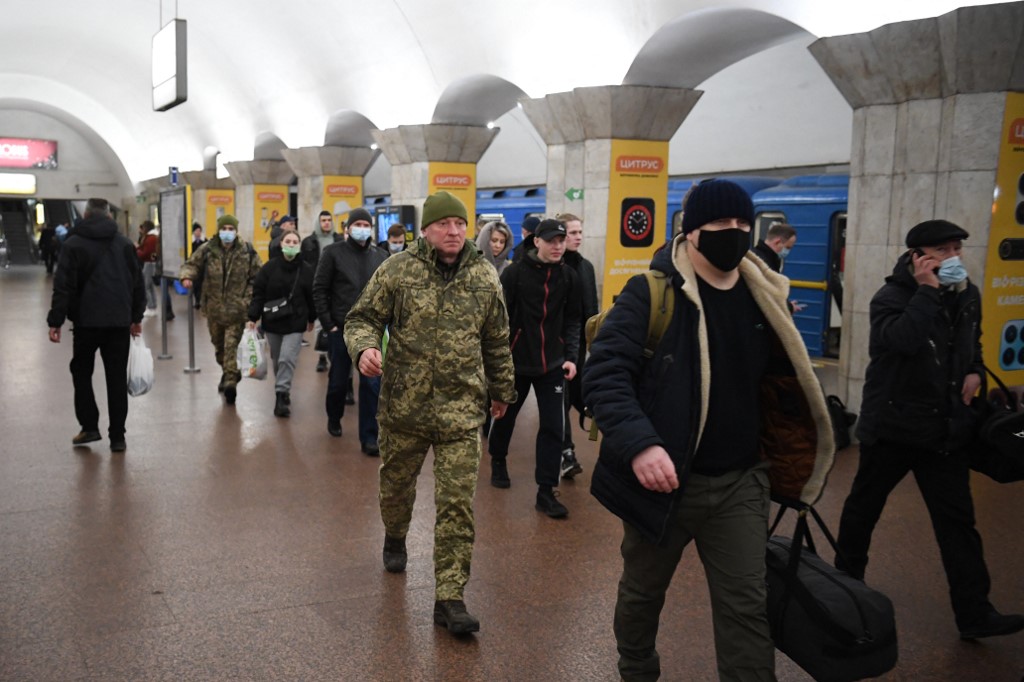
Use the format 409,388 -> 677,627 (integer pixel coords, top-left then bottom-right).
837,220 -> 1024,639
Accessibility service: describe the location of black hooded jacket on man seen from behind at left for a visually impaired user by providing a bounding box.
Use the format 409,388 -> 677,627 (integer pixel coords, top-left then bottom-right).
46,216 -> 145,328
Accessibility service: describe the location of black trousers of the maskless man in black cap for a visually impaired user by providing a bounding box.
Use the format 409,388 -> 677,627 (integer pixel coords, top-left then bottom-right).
487,368 -> 565,487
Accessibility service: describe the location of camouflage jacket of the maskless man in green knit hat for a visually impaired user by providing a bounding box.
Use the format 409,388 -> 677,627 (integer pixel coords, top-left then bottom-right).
345,239 -> 516,437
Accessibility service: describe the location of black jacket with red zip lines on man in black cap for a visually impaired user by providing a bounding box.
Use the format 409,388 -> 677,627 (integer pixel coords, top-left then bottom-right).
501,250 -> 582,377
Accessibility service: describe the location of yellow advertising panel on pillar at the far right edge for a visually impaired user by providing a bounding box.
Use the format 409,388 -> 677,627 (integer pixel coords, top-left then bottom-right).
981,92 -> 1024,390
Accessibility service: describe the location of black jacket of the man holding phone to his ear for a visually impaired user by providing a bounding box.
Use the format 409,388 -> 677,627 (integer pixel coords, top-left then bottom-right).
857,251 -> 984,452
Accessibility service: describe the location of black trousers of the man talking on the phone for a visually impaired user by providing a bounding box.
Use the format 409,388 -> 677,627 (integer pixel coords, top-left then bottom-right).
836,441 -> 992,628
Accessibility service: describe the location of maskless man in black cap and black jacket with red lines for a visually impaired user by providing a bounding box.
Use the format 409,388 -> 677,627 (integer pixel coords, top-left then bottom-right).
487,219 -> 581,518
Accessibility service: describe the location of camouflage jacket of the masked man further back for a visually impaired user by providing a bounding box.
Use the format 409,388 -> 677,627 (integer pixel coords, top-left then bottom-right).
178,237 -> 263,324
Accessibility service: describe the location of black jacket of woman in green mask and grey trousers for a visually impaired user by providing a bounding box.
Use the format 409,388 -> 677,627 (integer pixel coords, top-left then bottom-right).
249,256 -> 316,334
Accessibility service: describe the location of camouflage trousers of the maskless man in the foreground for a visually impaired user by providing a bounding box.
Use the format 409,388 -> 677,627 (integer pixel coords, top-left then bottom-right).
379,426 -> 480,600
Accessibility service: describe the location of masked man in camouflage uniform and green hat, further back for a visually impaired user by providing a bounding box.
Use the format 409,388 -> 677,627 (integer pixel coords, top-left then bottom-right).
178,215 -> 263,404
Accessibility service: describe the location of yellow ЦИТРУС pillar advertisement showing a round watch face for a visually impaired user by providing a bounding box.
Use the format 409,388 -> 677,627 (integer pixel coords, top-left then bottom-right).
601,139 -> 669,309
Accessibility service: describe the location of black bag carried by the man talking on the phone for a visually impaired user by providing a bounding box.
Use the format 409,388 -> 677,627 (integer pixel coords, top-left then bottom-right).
969,367 -> 1024,483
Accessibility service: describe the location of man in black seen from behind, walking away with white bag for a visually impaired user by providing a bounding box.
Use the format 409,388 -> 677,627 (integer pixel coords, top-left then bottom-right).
46,199 -> 145,453
